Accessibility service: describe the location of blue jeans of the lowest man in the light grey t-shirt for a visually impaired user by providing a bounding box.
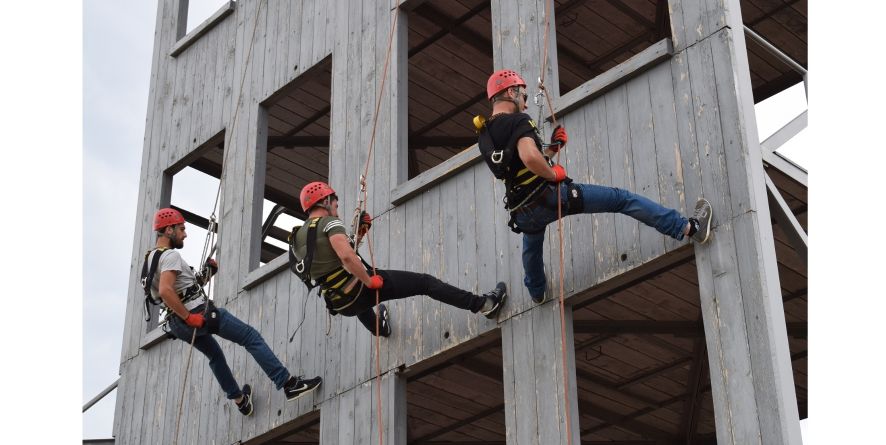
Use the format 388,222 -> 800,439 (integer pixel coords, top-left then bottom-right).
169,306 -> 289,399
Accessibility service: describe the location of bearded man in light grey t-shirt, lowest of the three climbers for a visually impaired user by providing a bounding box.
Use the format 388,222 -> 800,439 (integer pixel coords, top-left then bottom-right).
143,208 -> 323,416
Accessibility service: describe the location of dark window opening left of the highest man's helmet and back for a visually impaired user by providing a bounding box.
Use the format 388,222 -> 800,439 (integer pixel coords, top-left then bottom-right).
407,0 -> 493,179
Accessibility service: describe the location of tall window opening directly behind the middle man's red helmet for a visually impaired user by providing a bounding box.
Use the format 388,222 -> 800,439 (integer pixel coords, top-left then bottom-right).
256,56 -> 332,266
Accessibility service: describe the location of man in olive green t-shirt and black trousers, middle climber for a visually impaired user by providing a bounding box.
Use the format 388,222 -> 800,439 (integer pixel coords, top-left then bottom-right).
290,182 -> 507,337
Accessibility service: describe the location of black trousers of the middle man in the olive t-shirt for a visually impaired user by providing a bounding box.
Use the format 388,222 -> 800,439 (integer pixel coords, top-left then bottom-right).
341,269 -> 486,332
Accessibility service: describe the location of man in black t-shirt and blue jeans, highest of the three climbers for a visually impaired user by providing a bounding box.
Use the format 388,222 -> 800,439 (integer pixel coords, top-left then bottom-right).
475,70 -> 712,303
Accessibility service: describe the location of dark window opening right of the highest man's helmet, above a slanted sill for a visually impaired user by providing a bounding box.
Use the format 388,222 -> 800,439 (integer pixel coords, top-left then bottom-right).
554,0 -> 671,95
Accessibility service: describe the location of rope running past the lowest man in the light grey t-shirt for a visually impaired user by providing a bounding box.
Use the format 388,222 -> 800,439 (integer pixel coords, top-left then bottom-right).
172,0 -> 264,445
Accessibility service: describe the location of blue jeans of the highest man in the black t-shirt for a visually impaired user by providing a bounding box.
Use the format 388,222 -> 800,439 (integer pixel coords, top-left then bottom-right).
513,183 -> 688,296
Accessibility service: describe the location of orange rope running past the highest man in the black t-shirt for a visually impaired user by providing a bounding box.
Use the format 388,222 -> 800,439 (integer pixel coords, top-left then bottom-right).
538,0 -> 572,444
